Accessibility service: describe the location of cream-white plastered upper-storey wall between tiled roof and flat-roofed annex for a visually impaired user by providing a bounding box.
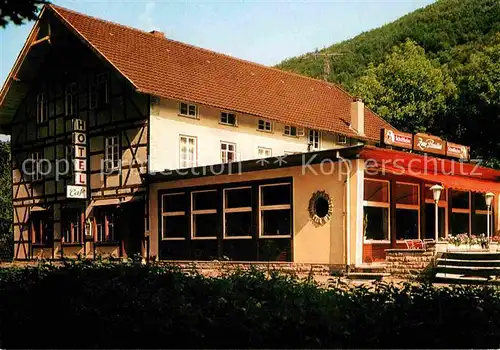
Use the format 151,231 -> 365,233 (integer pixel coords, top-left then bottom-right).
149,99 -> 350,172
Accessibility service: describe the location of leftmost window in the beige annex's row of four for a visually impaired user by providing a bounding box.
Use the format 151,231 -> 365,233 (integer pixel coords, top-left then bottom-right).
161,192 -> 188,240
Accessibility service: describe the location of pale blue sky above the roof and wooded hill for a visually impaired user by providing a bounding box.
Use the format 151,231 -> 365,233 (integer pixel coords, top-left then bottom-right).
0,0 -> 434,84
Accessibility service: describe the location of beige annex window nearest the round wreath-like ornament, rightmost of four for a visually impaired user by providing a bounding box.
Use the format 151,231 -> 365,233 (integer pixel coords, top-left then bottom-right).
259,183 -> 292,237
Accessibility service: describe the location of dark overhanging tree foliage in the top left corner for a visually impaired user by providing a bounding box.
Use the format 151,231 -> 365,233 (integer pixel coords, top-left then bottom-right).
0,0 -> 47,28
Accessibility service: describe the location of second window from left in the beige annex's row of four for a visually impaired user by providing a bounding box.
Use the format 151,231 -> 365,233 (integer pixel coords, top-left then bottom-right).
191,190 -> 219,239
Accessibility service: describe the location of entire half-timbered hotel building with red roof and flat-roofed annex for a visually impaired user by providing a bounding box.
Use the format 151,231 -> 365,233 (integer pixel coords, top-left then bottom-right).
0,5 -> 500,265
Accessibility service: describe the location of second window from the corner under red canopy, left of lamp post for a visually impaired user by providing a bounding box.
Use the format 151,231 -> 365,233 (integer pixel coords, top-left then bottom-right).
395,182 -> 420,239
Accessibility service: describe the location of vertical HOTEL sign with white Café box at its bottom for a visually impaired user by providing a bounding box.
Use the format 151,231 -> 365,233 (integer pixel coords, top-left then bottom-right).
66,119 -> 87,199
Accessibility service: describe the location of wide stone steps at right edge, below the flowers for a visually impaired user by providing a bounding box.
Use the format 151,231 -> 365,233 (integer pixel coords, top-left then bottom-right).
435,252 -> 500,285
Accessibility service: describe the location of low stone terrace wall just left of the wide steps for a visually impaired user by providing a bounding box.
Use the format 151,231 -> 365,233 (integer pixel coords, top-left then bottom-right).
385,249 -> 434,277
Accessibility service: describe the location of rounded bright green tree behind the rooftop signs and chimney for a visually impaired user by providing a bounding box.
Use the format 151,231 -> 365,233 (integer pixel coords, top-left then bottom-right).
353,40 -> 457,132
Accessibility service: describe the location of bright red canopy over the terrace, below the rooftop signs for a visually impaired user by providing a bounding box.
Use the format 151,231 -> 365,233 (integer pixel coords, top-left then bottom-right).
359,146 -> 500,193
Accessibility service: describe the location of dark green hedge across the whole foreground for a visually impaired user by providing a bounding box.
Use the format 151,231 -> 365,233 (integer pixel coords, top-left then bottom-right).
0,262 -> 500,348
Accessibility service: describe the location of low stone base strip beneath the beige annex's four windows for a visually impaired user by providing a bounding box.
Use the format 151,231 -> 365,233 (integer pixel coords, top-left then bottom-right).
161,260 -> 345,276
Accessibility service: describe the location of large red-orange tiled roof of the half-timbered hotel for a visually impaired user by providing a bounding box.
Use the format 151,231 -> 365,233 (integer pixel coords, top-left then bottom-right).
47,5 -> 390,140
